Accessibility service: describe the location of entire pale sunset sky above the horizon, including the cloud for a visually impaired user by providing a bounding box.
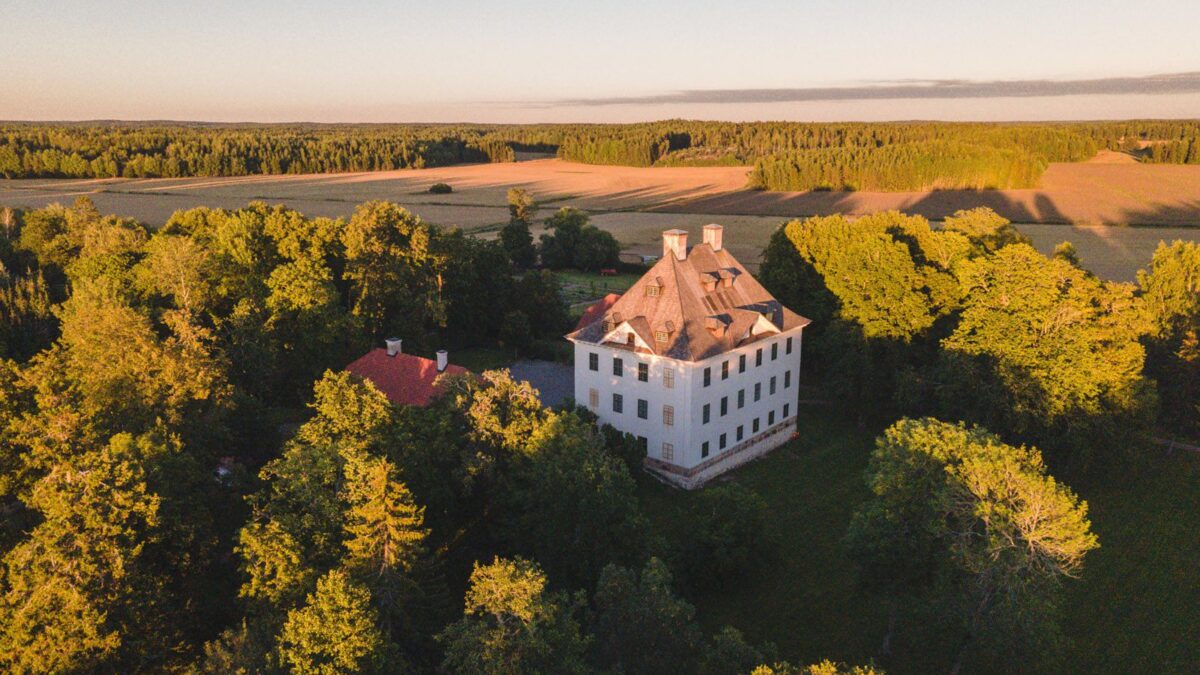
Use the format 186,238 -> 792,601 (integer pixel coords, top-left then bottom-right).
7,0 -> 1200,123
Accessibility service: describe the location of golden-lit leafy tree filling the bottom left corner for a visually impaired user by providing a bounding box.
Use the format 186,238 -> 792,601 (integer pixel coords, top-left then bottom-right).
0,436 -> 160,673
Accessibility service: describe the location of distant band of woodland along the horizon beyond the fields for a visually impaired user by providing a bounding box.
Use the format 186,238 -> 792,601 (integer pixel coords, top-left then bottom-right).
7,120 -> 1200,191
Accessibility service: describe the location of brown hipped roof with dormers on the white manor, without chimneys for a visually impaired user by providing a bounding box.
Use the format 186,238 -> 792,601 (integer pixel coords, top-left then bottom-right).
566,237 -> 809,360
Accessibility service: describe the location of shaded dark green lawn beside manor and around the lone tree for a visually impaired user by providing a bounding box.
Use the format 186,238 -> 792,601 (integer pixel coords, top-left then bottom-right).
641,410 -> 1200,673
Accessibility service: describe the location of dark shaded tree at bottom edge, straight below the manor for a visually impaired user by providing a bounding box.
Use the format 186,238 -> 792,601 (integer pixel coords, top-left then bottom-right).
589,557 -> 700,675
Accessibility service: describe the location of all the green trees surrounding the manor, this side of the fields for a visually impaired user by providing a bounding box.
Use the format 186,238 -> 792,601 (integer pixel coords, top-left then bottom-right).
0,184 -> 1200,675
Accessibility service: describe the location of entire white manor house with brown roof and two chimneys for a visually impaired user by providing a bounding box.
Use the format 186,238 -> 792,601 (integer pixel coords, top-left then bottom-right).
566,225 -> 809,488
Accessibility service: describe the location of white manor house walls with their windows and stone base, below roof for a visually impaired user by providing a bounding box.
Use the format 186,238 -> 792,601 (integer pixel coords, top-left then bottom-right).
575,327 -> 803,488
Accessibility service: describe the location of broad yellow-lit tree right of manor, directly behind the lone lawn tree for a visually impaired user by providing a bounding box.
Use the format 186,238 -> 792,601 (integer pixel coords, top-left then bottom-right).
937,244 -> 1154,461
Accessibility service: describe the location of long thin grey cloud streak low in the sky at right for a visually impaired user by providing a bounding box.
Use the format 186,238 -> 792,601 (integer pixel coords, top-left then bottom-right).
550,71 -> 1200,107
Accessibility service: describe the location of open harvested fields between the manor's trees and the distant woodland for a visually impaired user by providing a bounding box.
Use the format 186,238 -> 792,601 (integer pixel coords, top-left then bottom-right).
0,153 -> 1200,280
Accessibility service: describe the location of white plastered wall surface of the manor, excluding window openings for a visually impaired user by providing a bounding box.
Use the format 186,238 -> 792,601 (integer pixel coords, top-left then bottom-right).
575,328 -> 803,477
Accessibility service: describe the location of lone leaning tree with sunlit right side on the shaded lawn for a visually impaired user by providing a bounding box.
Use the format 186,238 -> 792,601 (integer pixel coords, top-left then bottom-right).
847,418 -> 1098,662
